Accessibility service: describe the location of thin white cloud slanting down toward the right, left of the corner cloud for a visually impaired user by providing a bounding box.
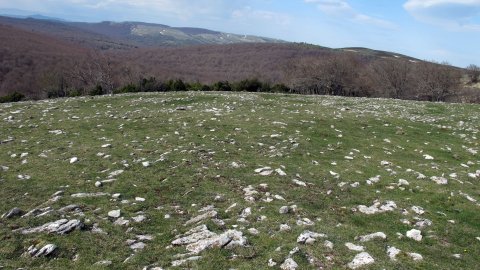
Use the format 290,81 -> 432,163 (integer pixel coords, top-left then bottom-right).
304,0 -> 395,29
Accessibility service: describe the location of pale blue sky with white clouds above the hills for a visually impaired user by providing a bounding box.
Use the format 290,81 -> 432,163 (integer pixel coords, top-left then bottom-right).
0,0 -> 480,67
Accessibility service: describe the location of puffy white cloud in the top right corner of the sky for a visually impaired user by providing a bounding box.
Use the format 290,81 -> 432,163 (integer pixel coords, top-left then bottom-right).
403,0 -> 480,31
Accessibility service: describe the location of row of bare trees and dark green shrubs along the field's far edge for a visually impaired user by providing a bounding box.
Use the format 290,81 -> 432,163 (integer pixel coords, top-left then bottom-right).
0,51 -> 480,103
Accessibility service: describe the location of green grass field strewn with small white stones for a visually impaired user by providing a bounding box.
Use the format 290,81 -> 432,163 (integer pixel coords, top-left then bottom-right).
0,92 -> 480,269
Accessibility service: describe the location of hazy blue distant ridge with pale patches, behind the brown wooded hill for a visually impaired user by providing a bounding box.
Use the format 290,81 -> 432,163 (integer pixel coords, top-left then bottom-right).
0,15 -> 286,50
